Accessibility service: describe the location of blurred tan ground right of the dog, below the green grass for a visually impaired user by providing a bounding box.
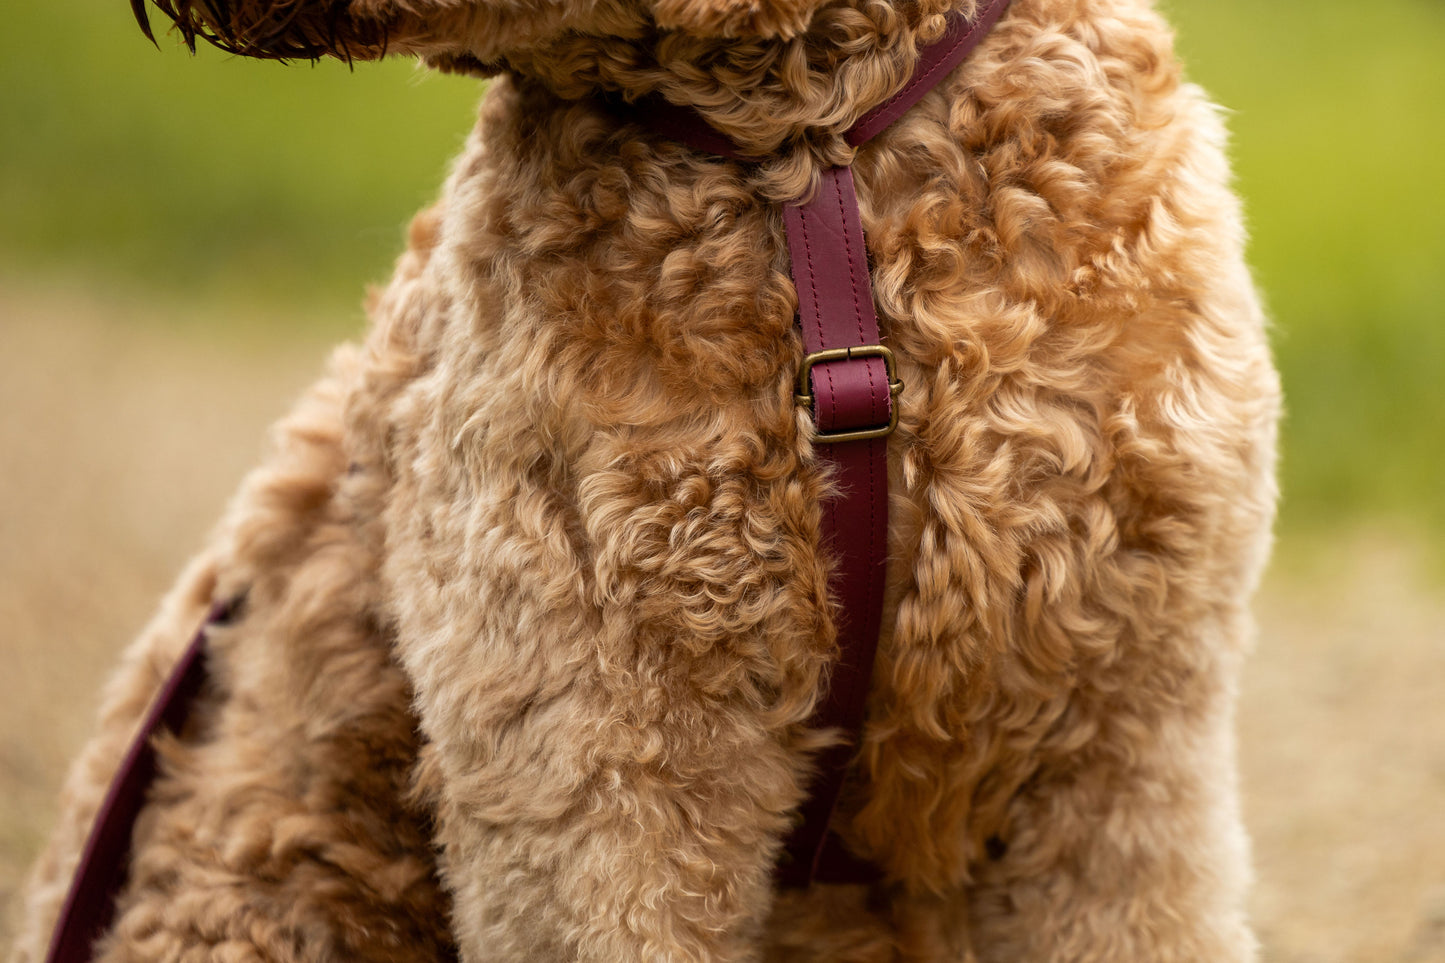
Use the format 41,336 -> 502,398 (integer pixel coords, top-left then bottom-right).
1240,536 -> 1445,963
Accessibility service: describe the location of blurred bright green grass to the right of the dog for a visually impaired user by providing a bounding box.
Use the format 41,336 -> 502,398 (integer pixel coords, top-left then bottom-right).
1165,0 -> 1445,552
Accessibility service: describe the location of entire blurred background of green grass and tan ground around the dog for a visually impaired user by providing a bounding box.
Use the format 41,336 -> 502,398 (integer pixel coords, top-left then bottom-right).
0,0 -> 1445,963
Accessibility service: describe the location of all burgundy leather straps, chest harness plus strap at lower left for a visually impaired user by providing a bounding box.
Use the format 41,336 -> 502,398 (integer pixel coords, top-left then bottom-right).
46,0 -> 1009,963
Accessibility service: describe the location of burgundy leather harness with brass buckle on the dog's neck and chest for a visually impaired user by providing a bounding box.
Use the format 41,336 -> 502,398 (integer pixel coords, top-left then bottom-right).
627,0 -> 1009,886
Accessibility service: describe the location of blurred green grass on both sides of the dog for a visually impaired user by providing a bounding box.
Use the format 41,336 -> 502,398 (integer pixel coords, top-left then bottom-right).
0,0 -> 1445,543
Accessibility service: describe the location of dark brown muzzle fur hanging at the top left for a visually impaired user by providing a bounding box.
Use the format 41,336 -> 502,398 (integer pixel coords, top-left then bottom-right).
130,0 -> 390,61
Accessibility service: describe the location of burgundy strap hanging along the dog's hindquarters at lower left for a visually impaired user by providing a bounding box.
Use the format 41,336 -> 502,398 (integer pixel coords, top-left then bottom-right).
45,600 -> 238,963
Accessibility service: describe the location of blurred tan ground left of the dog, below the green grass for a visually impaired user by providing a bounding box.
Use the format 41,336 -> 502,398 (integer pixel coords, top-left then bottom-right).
0,279 -> 339,931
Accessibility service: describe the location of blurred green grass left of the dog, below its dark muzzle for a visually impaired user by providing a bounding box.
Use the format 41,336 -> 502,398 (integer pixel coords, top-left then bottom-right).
0,0 -> 480,318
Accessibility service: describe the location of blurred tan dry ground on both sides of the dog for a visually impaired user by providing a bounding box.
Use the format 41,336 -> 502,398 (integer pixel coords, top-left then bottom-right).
0,279 -> 1445,963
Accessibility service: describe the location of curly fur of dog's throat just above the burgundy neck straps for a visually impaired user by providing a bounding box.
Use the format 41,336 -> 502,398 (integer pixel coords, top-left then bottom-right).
491,0 -> 975,163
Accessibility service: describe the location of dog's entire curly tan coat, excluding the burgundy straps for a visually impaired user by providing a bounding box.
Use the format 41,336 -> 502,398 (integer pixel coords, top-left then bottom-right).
13,0 -> 1279,963
